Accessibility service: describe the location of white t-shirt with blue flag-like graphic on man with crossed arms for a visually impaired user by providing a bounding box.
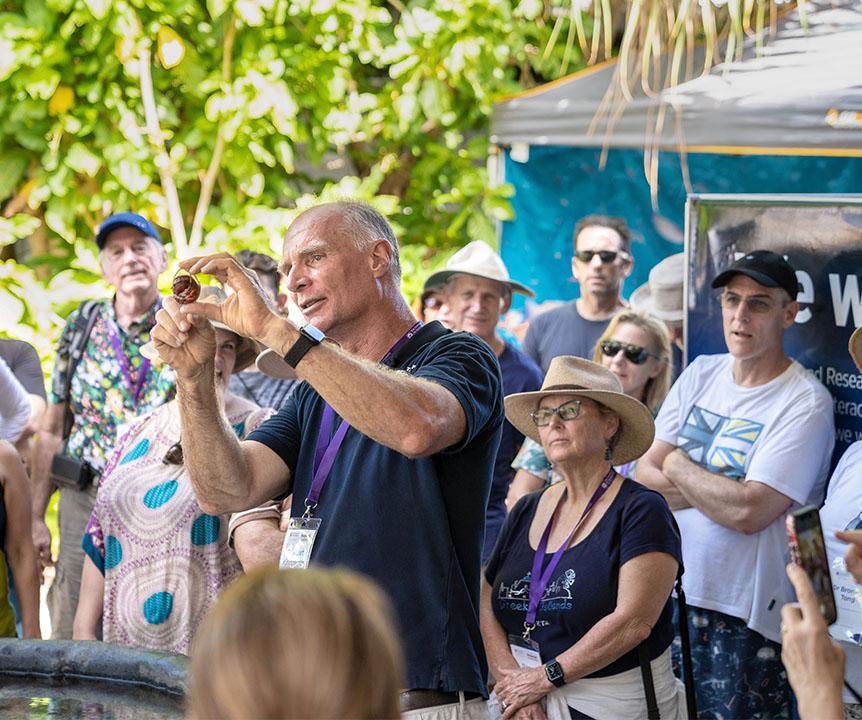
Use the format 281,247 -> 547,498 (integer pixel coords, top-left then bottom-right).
656,354 -> 835,642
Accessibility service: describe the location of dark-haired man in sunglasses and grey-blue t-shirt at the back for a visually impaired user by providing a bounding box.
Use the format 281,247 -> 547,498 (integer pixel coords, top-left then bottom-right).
524,215 -> 634,372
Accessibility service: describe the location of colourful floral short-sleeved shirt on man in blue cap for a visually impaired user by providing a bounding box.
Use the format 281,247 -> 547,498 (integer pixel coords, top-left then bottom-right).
49,302 -> 174,472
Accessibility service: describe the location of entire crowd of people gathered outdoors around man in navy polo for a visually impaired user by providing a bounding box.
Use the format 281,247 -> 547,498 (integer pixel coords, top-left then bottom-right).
0,201 -> 862,720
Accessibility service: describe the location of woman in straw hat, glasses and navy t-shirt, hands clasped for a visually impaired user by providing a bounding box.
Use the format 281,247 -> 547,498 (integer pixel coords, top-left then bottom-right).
481,356 -> 682,720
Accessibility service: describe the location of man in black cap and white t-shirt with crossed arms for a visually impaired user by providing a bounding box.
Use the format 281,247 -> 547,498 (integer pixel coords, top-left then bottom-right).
637,250 -> 835,717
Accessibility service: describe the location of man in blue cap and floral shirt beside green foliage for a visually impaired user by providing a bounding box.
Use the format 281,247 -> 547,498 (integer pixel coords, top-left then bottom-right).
32,212 -> 173,639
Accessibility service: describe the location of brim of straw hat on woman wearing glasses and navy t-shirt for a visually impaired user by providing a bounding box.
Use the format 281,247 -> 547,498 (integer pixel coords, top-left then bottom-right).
504,389 -> 655,465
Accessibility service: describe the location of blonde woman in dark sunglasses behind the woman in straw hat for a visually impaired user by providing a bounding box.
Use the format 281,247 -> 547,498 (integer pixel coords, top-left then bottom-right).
506,310 -> 673,508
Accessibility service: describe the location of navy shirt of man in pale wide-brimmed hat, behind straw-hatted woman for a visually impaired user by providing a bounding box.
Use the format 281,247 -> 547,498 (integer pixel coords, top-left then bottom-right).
490,343 -> 543,561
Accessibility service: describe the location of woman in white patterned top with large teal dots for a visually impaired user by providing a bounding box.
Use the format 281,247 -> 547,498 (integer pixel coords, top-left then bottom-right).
73,287 -> 272,654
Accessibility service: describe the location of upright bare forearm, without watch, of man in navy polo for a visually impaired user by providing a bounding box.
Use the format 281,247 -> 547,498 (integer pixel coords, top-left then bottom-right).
177,373 -> 255,514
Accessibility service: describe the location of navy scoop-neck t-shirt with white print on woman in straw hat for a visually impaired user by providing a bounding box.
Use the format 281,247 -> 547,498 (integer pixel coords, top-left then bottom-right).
485,479 -> 682,677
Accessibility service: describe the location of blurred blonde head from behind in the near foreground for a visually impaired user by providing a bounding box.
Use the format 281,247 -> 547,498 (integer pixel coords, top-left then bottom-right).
189,567 -> 403,720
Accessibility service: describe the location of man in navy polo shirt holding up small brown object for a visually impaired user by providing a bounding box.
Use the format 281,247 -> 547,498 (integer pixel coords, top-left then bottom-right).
153,202 -> 503,717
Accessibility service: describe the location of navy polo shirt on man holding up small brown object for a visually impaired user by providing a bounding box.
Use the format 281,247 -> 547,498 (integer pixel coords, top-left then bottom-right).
248,322 -> 503,694
